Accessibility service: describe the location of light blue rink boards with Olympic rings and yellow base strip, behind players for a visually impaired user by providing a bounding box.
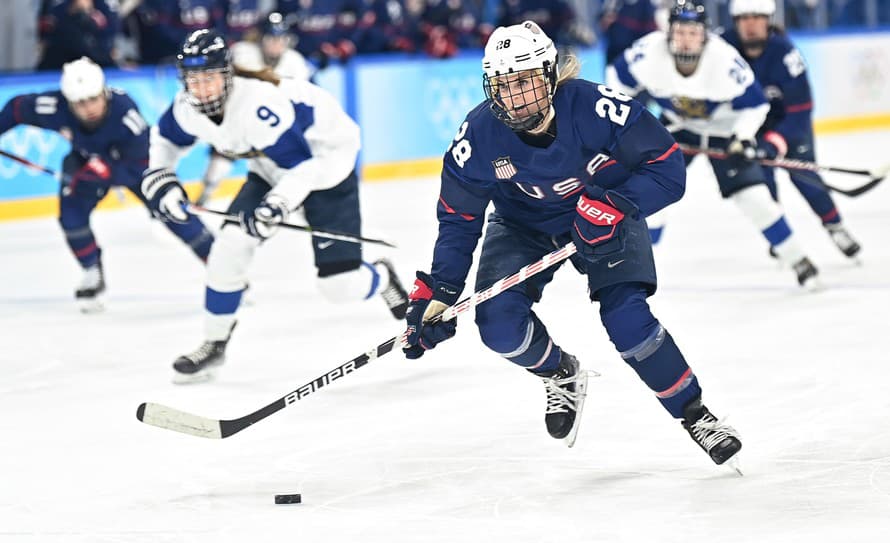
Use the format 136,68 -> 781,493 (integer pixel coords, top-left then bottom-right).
0,32 -> 890,220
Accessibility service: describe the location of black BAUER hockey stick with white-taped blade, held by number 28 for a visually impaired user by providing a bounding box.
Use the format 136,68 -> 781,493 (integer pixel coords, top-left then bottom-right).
136,243 -> 576,439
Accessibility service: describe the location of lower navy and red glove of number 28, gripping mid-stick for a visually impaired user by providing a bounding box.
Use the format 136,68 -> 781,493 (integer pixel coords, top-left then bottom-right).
402,272 -> 463,360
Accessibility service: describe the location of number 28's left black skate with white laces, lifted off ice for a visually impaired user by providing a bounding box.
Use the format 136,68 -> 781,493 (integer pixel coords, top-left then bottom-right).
535,351 -> 587,447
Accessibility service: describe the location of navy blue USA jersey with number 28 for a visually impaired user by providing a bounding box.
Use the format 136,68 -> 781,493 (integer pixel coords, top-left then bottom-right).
432,79 -> 686,285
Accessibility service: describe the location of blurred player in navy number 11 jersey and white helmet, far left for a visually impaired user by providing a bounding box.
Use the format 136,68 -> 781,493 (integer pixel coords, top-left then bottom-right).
0,57 -> 213,312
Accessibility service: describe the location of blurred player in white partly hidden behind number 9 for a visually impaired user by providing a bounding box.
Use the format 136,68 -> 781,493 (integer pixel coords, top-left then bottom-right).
196,12 -> 315,205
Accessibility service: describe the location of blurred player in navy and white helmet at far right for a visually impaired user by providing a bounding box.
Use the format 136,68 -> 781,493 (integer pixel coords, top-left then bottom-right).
723,0 -> 860,258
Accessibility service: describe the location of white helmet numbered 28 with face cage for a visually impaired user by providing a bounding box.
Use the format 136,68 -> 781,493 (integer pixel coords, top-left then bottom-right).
482,21 -> 558,131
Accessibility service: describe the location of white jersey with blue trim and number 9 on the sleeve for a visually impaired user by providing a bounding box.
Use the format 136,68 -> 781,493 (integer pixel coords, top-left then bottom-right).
149,77 -> 361,208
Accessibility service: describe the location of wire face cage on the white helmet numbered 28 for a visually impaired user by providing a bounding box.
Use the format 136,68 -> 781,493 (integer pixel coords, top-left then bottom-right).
482,61 -> 556,132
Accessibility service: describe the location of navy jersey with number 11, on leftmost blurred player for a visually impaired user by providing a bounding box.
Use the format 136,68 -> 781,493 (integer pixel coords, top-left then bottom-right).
0,90 -> 148,185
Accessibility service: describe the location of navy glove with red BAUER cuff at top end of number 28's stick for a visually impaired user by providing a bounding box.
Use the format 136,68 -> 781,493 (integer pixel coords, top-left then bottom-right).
572,187 -> 638,262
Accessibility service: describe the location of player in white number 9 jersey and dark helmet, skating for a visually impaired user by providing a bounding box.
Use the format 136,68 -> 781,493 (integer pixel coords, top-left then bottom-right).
142,30 -> 407,382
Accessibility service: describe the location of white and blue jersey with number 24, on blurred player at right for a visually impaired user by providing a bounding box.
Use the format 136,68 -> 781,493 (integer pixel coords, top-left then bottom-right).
606,31 -> 769,140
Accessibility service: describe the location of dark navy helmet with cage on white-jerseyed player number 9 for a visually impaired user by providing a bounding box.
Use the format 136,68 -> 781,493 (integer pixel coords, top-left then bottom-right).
176,29 -> 232,117
